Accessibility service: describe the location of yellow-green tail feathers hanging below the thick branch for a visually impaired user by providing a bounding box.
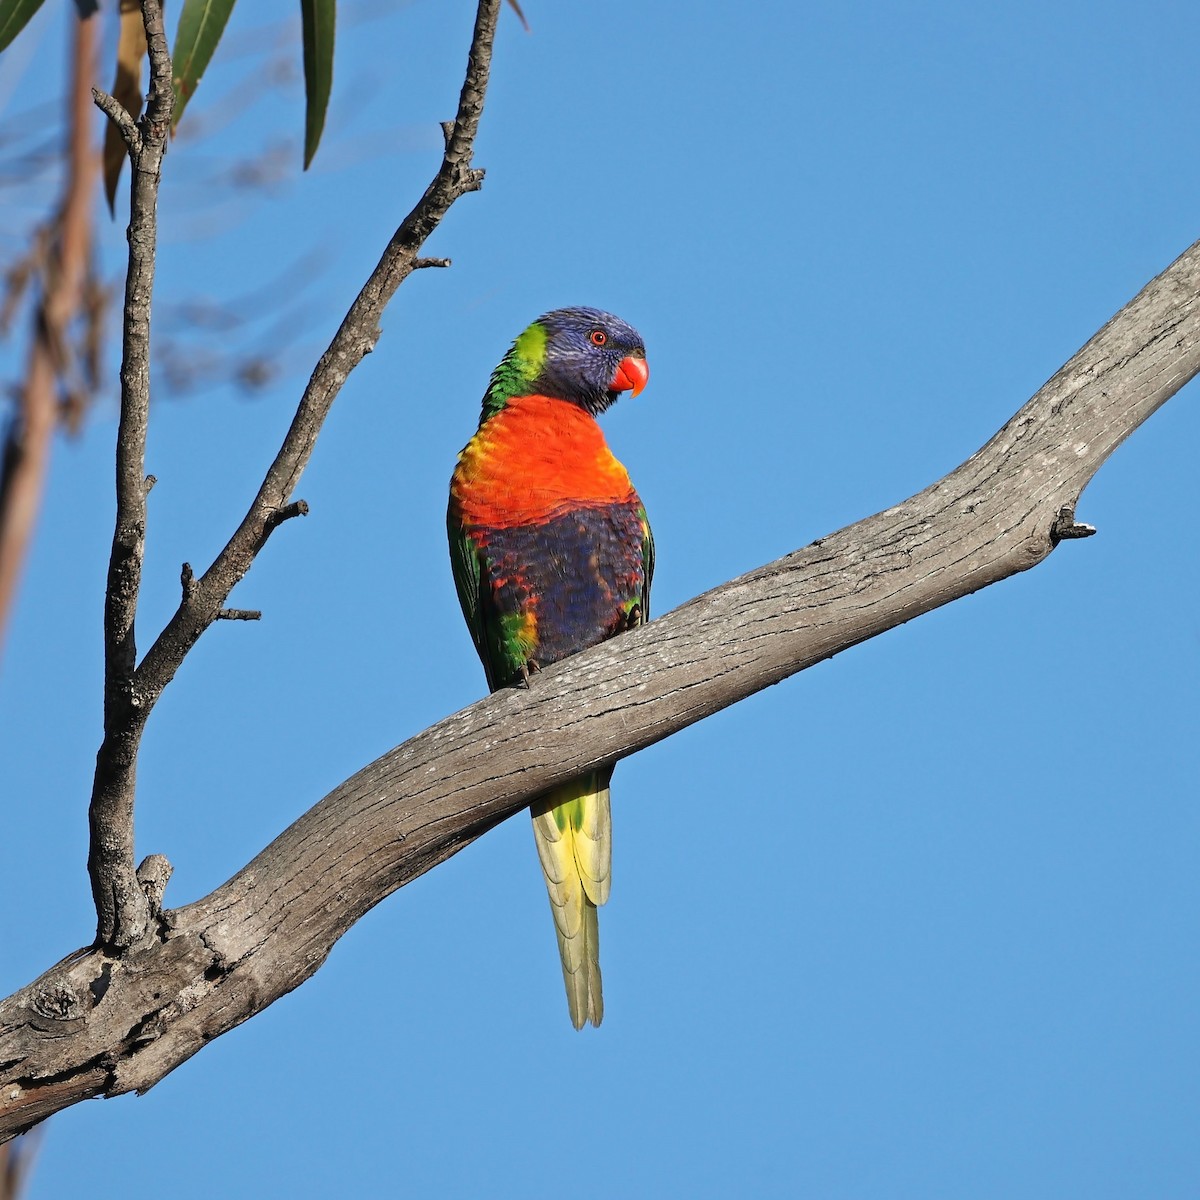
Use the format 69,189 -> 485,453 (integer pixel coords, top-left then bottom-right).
529,767 -> 612,1030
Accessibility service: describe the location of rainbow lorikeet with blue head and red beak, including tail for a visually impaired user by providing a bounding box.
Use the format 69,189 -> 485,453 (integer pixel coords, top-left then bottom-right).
446,308 -> 654,1030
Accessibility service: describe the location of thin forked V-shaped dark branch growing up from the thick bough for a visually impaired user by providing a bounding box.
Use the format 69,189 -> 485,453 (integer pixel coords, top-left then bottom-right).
82,0 -> 500,950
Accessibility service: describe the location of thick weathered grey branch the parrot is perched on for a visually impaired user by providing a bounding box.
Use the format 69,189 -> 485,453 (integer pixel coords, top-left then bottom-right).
0,234 -> 1200,1140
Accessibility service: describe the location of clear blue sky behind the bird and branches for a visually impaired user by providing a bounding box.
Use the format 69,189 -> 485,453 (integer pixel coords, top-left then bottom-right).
0,0 -> 1200,1200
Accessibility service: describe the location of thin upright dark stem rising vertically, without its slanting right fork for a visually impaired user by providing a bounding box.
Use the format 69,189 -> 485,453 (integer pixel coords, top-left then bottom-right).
88,0 -> 175,947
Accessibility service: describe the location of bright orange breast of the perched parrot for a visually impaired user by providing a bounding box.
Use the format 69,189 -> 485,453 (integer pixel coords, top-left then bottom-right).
450,396 -> 634,529
